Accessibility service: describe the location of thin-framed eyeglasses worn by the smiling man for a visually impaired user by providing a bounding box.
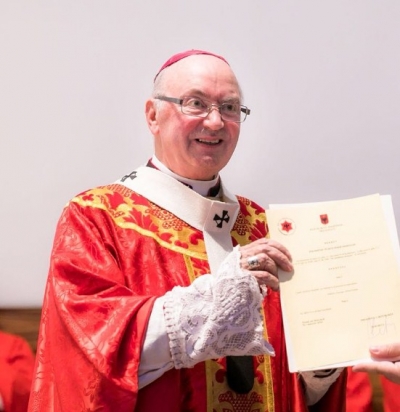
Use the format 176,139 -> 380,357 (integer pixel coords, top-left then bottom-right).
156,96 -> 250,123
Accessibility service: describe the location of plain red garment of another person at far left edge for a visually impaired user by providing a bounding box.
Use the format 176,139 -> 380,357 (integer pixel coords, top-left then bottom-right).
0,331 -> 34,412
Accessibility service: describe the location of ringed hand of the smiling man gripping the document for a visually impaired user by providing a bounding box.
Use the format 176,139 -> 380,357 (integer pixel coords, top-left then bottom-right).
240,239 -> 293,290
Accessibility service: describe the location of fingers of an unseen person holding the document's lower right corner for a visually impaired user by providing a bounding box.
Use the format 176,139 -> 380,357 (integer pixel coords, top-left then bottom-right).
353,342 -> 400,384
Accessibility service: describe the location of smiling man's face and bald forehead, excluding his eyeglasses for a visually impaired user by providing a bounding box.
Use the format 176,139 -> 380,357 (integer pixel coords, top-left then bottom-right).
146,55 -> 240,180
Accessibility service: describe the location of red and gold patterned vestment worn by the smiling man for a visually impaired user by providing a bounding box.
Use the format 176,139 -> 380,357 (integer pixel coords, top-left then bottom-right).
29,184 -> 345,412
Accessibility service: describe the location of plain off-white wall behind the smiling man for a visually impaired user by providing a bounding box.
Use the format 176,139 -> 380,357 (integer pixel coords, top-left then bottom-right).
0,0 -> 400,307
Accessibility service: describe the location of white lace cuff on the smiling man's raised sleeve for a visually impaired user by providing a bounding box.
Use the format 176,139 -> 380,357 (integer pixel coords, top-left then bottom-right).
164,247 -> 275,369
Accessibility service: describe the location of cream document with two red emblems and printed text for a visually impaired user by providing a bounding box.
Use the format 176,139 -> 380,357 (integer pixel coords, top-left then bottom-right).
267,195 -> 400,372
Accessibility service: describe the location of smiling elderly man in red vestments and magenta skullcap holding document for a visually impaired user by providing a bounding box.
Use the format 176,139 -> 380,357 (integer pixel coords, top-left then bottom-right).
30,50 -> 345,412
